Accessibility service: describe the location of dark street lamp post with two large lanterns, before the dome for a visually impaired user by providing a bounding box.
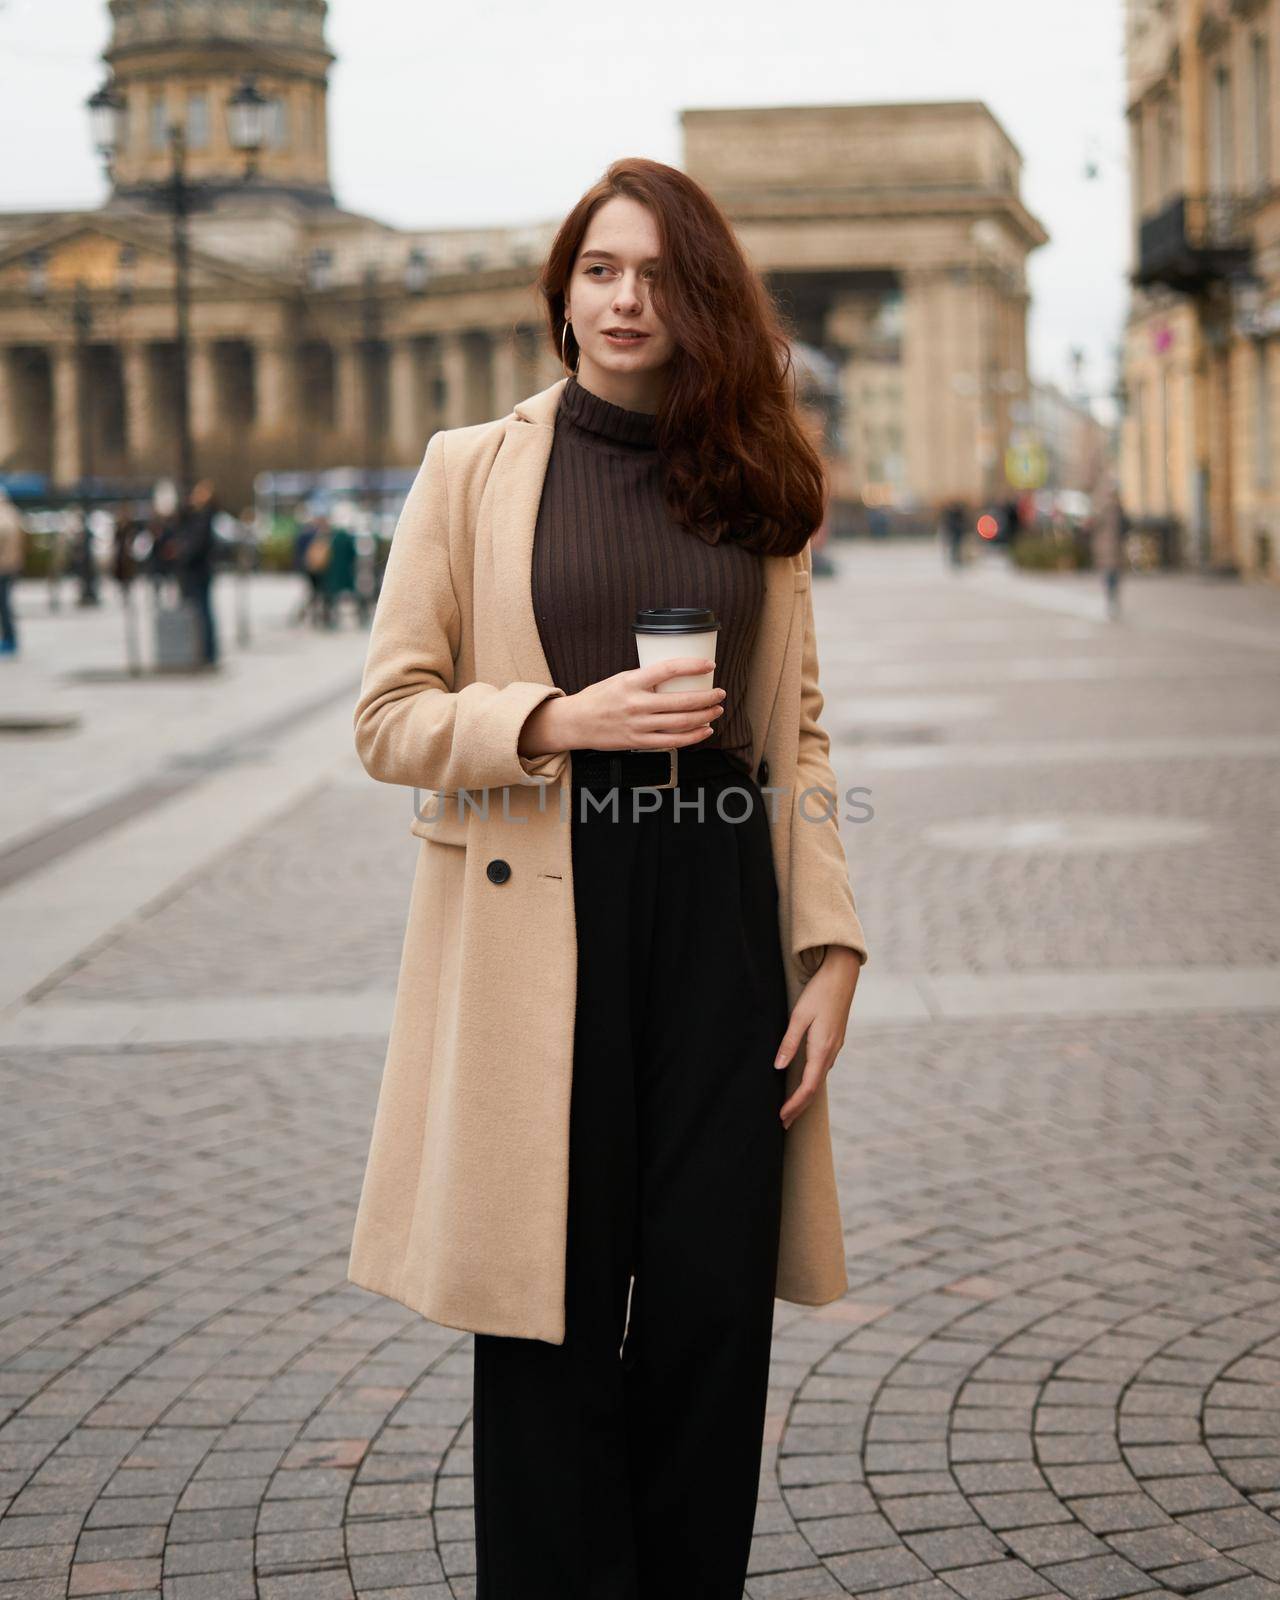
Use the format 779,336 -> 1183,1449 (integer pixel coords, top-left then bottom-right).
88,75 -> 269,499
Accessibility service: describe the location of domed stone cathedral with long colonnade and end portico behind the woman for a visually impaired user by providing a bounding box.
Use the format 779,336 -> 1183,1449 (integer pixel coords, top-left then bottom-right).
0,0 -> 1046,506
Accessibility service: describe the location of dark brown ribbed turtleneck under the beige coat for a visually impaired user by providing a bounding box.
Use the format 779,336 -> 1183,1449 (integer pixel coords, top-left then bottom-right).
533,378 -> 763,770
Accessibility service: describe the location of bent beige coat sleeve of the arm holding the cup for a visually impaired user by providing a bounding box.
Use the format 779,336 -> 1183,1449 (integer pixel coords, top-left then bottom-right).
355,432 -> 568,790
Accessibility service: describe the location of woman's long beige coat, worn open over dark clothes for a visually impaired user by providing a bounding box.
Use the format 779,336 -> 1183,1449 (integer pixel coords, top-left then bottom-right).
347,379 -> 866,1344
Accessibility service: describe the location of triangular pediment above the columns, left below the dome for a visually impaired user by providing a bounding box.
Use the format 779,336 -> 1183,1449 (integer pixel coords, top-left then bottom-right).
0,214 -> 286,296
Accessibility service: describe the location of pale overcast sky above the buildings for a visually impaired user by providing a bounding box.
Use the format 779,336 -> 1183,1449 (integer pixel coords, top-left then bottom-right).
0,0 -> 1128,412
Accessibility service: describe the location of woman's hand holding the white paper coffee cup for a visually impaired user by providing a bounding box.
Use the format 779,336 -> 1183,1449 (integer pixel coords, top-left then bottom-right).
522,656 -> 725,754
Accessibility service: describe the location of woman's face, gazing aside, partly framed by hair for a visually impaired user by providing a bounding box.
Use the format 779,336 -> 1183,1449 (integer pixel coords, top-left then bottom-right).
565,195 -> 675,411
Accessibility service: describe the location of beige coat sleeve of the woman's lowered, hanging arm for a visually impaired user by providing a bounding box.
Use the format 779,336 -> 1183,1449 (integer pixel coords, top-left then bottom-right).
790,546 -> 867,978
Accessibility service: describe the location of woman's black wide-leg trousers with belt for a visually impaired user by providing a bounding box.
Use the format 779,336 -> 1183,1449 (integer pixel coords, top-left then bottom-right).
474,749 -> 789,1600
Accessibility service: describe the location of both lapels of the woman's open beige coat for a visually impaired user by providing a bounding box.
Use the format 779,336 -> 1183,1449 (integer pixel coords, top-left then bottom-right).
488,378 -> 798,771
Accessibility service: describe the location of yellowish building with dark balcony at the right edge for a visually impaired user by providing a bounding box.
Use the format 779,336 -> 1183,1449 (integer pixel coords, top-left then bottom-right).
1122,0 -> 1280,579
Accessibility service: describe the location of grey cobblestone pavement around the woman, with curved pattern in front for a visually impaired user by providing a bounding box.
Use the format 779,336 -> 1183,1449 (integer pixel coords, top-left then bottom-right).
0,549 -> 1280,1600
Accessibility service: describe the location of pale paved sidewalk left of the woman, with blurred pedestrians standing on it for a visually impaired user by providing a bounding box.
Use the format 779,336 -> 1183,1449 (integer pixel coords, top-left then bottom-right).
0,574 -> 368,1011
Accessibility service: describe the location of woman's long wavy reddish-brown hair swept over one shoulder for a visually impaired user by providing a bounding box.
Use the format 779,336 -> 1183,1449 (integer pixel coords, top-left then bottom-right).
538,157 -> 827,555
